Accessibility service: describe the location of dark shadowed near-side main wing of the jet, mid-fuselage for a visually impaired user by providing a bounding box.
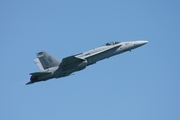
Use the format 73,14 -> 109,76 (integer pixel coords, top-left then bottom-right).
59,55 -> 84,67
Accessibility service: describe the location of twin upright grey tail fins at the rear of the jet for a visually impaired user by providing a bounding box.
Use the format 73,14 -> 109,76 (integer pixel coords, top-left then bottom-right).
35,51 -> 61,70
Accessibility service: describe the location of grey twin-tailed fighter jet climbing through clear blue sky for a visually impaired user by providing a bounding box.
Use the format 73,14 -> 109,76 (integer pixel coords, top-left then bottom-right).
26,40 -> 148,85
